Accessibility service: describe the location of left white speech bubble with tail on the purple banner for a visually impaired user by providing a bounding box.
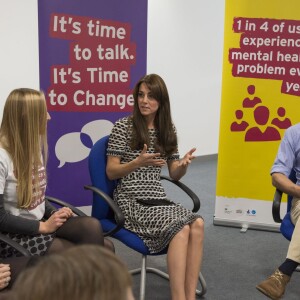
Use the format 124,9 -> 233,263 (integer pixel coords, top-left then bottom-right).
55,132 -> 90,168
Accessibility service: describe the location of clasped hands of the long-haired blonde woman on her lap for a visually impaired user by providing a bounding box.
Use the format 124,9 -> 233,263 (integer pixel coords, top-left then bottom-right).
39,207 -> 73,234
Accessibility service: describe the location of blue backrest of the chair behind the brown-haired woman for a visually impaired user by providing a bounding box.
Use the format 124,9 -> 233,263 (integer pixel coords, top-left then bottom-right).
88,136 -> 117,220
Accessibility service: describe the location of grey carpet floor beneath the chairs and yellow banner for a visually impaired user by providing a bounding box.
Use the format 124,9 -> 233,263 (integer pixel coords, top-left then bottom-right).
110,156 -> 300,300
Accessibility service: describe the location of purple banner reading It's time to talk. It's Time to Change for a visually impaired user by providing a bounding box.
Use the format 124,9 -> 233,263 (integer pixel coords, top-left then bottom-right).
38,0 -> 147,206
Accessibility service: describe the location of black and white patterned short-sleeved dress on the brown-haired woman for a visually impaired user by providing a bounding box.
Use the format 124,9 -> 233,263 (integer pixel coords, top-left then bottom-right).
107,117 -> 201,253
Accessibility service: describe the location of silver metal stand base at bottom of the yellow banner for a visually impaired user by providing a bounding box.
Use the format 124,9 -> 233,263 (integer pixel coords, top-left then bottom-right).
213,217 -> 280,233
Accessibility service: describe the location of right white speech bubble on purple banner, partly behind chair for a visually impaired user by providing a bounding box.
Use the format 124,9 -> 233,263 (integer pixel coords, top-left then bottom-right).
81,120 -> 113,144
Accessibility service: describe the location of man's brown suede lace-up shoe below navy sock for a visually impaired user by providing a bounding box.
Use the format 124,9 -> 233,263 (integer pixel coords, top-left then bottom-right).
256,269 -> 291,300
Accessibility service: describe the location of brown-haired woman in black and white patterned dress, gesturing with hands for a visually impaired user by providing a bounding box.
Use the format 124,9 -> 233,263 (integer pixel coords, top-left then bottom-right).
106,74 -> 204,300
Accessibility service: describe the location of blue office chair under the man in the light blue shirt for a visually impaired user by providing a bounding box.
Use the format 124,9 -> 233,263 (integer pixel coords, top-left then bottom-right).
272,170 -> 297,241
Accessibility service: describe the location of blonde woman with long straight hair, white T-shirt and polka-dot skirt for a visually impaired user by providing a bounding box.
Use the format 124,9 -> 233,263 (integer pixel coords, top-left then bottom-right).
0,88 -> 110,286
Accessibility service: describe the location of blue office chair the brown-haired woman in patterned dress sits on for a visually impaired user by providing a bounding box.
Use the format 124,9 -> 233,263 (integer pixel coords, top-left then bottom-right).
85,136 -> 206,300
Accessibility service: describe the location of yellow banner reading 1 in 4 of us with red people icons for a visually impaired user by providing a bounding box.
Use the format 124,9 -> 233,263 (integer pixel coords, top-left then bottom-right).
215,0 -> 300,227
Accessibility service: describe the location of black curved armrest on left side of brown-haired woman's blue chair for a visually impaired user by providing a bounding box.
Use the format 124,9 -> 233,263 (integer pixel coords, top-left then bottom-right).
84,185 -> 125,236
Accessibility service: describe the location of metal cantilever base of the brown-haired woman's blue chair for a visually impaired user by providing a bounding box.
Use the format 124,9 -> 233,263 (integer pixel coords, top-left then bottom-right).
129,255 -> 207,300
